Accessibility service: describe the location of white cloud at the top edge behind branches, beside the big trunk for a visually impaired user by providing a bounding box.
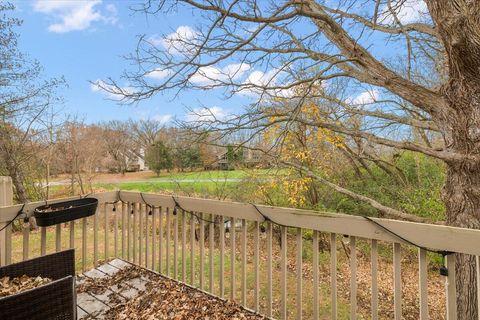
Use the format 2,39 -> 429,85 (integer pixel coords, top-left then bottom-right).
381,0 -> 428,24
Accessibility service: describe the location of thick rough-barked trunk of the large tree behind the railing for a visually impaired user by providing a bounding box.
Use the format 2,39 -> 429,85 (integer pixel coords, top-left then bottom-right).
426,0 -> 480,319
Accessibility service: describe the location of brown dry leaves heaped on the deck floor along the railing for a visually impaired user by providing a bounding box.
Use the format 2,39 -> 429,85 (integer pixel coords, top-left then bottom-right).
79,266 -> 266,320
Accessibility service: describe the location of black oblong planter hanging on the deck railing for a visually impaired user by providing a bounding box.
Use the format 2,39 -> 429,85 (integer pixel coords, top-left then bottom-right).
33,198 -> 98,227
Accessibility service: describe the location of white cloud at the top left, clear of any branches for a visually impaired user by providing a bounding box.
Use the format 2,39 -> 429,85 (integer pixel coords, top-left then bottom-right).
33,0 -> 117,33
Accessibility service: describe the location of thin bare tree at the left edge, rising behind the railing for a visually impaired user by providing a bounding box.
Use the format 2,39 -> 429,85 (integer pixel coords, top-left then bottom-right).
0,3 -> 64,202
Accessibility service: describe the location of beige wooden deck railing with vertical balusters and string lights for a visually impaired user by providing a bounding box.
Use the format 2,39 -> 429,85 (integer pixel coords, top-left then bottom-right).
0,179 -> 480,319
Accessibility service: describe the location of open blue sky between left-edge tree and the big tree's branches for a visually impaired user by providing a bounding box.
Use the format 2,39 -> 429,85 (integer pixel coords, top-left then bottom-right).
14,0 -> 247,123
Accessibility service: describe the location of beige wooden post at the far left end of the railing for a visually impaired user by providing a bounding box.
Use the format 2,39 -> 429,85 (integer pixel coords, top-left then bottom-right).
0,177 -> 13,266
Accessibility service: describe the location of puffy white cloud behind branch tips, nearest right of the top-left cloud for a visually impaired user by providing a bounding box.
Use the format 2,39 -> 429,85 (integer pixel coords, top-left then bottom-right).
149,26 -> 199,55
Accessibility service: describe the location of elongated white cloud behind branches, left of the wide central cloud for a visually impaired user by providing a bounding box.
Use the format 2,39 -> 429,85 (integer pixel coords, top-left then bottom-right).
190,63 -> 250,86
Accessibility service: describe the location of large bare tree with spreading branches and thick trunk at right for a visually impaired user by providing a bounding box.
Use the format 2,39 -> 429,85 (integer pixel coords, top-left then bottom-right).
103,0 -> 480,319
